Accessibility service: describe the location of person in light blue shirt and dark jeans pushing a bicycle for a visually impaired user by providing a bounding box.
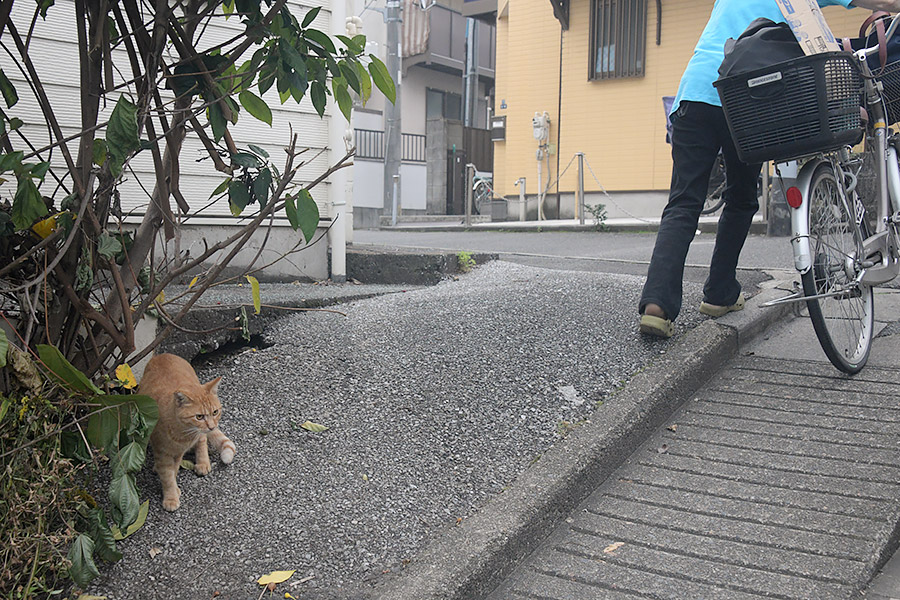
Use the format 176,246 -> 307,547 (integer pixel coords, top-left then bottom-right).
638,0 -> 900,337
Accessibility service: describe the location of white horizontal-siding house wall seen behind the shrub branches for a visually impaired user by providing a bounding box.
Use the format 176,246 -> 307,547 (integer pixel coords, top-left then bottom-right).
0,0 -> 342,282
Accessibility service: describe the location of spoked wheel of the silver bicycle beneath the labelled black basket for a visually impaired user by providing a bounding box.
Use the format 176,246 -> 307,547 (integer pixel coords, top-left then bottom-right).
802,165 -> 874,374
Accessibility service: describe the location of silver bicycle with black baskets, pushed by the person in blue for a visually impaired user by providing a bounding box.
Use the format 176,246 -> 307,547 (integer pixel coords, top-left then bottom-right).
716,16 -> 900,374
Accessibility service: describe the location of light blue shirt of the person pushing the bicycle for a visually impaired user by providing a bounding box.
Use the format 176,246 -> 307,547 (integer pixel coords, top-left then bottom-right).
671,0 -> 853,113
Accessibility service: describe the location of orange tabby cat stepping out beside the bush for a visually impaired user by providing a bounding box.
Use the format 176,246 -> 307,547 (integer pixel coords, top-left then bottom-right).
139,354 -> 236,511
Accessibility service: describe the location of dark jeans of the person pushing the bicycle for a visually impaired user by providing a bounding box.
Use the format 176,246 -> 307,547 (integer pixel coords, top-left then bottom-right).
638,102 -> 762,320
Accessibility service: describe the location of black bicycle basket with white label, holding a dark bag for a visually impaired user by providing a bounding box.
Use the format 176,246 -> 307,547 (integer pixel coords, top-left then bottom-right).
714,52 -> 864,163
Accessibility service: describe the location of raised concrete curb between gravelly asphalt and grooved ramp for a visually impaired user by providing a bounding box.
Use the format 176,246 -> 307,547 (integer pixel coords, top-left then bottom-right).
372,286 -> 792,600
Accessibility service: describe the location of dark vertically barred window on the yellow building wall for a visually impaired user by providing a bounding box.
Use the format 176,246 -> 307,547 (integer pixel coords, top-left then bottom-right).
589,0 -> 647,79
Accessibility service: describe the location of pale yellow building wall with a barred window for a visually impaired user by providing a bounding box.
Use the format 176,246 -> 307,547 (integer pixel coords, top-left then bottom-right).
494,0 -> 869,197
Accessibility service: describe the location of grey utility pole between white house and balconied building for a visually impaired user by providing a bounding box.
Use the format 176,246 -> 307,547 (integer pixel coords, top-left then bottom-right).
382,0 -> 403,214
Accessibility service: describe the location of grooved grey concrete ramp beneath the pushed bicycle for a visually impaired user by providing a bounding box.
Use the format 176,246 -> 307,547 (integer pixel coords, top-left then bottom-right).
490,291 -> 900,600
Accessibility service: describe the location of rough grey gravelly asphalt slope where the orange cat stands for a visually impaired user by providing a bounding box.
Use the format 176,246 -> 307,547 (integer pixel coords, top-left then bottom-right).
91,262 -> 702,600
